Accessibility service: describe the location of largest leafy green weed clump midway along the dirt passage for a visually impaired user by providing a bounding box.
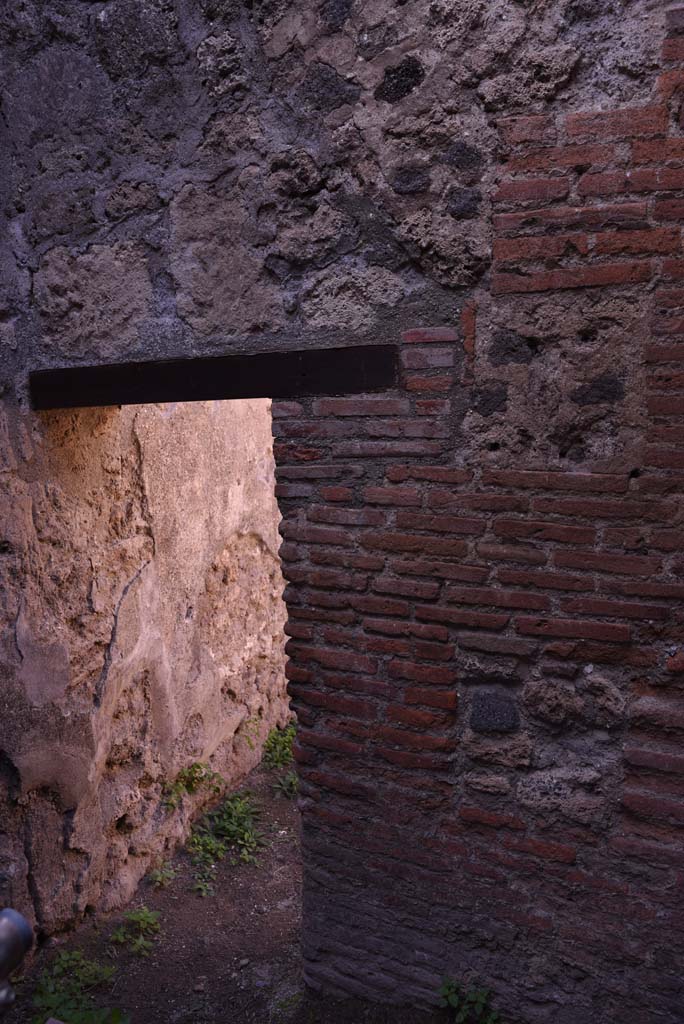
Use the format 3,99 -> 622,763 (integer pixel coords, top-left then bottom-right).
187,793 -> 264,896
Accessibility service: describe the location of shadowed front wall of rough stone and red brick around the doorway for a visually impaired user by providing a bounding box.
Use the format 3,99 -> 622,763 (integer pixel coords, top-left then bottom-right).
0,0 -> 684,1024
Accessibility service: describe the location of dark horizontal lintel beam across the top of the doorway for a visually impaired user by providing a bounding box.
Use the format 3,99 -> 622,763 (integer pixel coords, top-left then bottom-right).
29,345 -> 398,410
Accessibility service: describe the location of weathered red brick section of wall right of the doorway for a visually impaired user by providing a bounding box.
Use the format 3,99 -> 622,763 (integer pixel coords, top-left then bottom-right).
274,8 -> 684,1024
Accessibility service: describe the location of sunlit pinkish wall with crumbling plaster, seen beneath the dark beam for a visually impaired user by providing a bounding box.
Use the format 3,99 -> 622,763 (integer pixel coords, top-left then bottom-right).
0,399 -> 287,933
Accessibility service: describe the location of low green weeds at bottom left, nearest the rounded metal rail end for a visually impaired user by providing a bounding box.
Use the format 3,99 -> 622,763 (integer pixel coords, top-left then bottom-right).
32,949 -> 130,1024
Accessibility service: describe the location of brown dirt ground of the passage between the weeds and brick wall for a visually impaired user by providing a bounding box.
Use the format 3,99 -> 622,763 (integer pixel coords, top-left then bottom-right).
6,769 -> 444,1024
